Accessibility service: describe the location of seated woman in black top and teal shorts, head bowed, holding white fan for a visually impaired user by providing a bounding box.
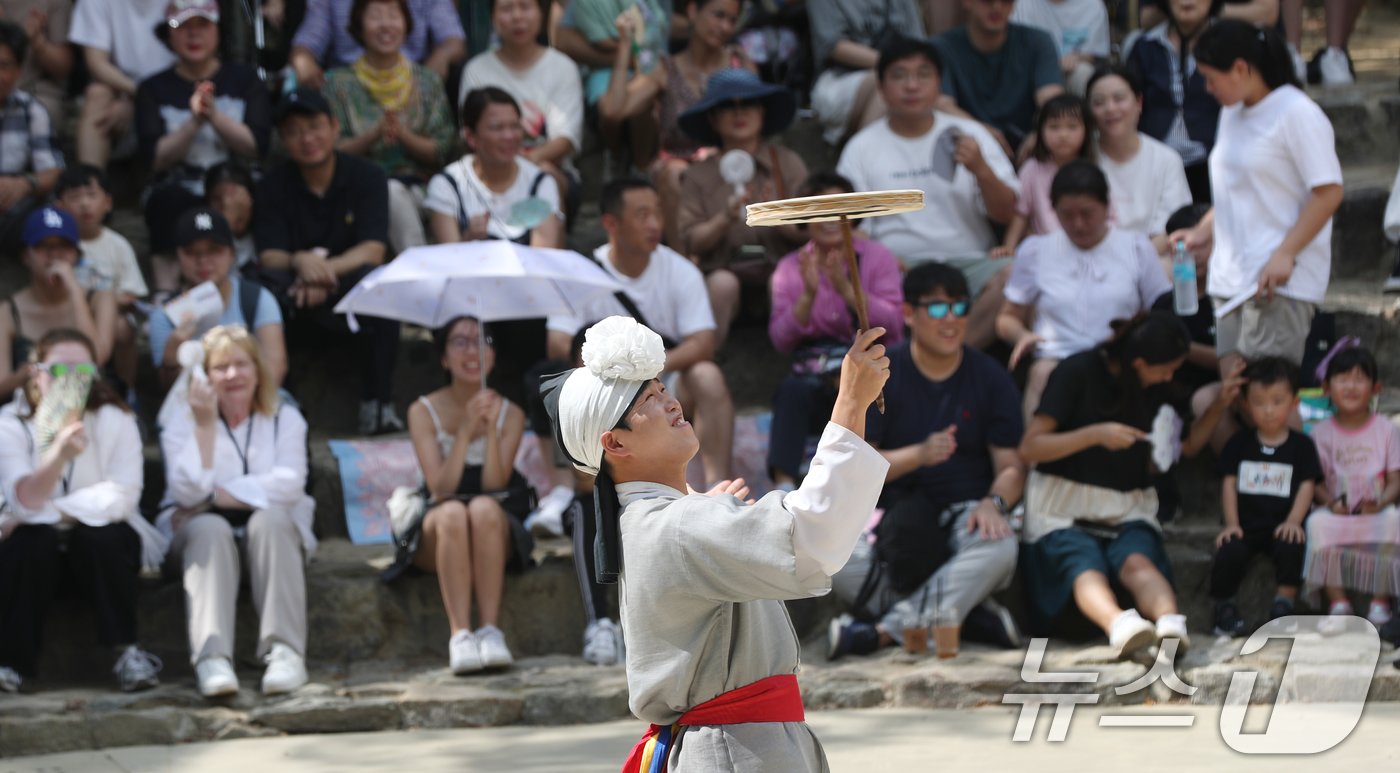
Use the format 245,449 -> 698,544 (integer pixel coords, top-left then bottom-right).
1021,312 -> 1240,658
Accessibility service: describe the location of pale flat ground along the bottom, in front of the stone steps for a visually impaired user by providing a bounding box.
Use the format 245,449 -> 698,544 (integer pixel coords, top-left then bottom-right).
0,704 -> 1400,773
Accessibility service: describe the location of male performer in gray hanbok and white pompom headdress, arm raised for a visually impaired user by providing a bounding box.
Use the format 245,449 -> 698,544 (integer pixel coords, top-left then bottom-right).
545,316 -> 889,773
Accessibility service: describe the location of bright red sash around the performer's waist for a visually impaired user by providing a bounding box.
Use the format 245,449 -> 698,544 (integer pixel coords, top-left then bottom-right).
622,674 -> 806,773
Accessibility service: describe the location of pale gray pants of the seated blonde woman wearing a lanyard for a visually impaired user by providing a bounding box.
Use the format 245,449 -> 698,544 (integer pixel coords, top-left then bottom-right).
171,510 -> 307,662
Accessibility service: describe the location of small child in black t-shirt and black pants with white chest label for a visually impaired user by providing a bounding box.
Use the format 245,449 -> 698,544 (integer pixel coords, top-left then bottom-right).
1211,357 -> 1322,636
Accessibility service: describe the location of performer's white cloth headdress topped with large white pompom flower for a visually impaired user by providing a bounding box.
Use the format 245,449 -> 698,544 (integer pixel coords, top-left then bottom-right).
556,316 -> 666,476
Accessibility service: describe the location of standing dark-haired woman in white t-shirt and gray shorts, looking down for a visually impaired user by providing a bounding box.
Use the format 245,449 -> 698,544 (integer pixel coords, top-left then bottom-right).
1172,20 -> 1343,372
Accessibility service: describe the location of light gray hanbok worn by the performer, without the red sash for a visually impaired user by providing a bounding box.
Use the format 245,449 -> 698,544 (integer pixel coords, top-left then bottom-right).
617,424 -> 889,773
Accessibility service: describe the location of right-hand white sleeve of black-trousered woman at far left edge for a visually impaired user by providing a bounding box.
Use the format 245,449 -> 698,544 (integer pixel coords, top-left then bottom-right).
53,405 -> 146,527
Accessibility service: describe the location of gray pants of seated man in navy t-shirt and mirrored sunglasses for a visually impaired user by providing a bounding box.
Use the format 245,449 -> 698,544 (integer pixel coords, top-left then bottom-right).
832,507 -> 1016,643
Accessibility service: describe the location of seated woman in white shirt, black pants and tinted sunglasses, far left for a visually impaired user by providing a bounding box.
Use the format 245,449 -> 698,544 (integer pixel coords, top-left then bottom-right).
0,328 -> 165,693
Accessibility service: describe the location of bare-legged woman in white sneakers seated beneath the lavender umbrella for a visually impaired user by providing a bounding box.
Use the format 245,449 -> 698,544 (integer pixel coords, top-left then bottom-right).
385,316 -> 533,675
